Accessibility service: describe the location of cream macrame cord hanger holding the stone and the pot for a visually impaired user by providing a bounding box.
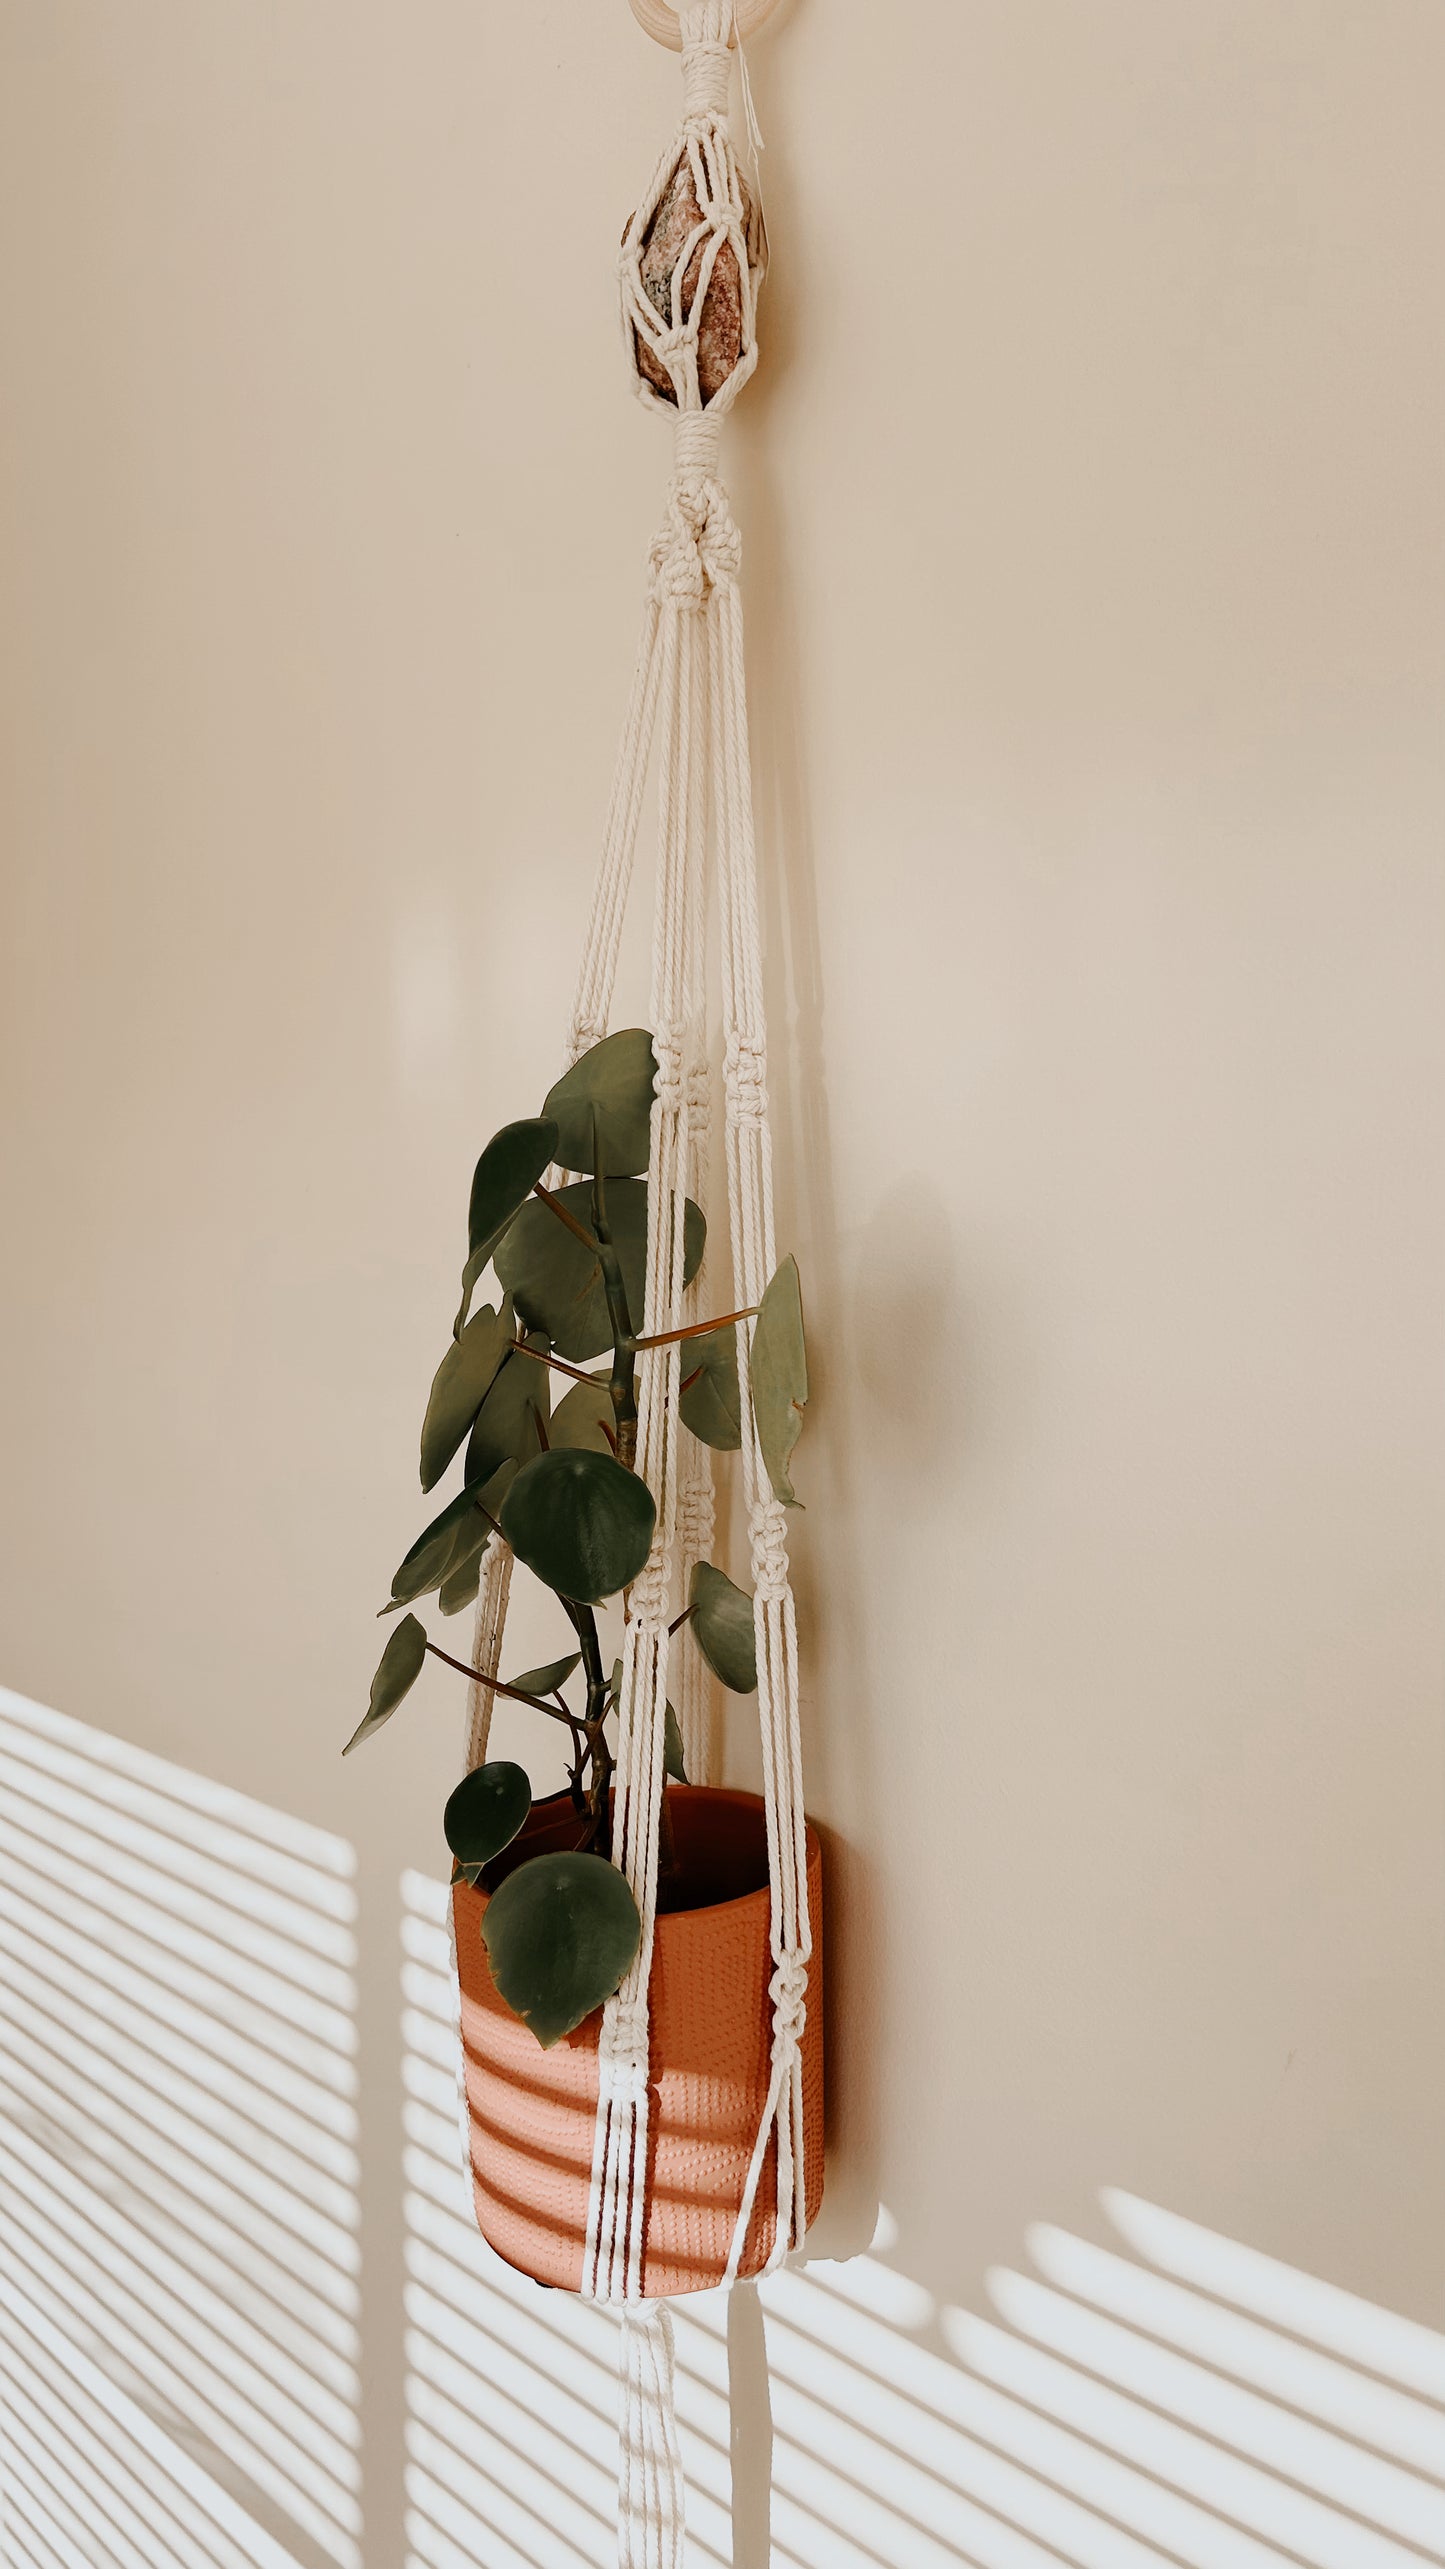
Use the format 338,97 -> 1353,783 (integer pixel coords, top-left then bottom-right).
455,0 -> 812,2569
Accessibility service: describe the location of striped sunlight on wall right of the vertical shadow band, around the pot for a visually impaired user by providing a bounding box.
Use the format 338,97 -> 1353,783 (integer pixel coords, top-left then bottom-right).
404,1875 -> 1445,2569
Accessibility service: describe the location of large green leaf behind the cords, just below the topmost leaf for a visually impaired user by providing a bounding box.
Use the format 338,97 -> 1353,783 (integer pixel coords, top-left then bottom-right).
496,1177 -> 707,1364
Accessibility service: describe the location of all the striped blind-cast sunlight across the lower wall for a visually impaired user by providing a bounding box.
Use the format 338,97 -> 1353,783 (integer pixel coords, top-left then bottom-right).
0,1726 -> 1445,2569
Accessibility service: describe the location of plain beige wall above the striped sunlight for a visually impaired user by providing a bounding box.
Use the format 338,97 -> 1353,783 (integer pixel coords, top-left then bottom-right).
0,0 -> 1445,2569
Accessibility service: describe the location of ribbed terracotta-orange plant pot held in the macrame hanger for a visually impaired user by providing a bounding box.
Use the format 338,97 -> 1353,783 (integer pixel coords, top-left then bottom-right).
453,1785 -> 823,2299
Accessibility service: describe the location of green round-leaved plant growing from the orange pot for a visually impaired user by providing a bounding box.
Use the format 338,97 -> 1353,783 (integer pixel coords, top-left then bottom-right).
347,1028 -> 807,2047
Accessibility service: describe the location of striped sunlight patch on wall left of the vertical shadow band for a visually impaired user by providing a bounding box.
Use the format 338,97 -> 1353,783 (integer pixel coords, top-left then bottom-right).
0,1690 -> 363,2569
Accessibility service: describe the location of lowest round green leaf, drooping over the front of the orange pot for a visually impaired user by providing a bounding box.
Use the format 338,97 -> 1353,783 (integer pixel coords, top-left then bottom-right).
481,1855 -> 643,2050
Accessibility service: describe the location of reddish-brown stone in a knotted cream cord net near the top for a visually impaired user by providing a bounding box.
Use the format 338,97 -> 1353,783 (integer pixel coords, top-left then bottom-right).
617,65 -> 766,411
